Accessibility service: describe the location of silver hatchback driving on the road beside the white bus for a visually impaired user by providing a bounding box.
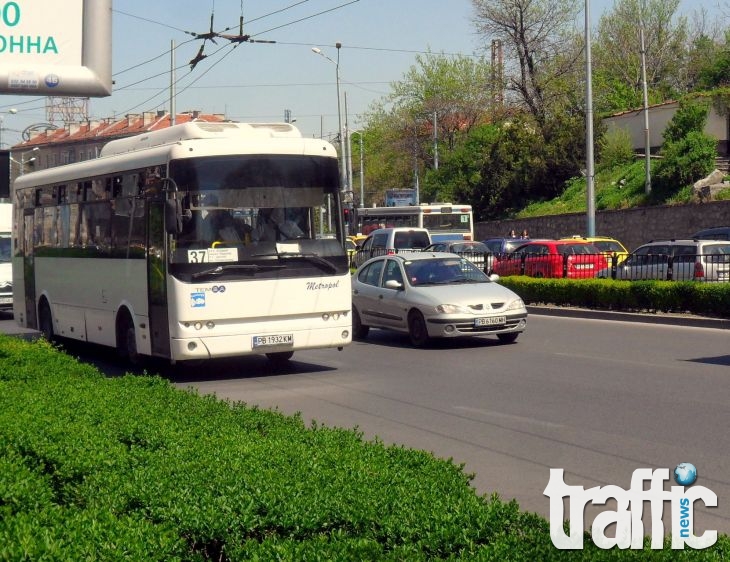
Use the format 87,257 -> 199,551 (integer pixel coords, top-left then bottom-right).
352,252 -> 527,347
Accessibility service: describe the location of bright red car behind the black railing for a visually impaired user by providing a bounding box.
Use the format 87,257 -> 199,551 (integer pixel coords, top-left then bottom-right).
494,240 -> 608,279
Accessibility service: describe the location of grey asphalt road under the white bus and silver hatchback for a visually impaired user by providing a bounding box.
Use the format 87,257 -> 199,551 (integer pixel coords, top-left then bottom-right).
0,308 -> 730,534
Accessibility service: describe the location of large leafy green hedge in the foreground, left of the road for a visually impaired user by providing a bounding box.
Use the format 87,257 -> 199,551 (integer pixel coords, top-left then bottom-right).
0,336 -> 730,561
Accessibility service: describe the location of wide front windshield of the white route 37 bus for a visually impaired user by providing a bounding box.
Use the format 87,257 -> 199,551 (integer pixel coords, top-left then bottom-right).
169,155 -> 345,276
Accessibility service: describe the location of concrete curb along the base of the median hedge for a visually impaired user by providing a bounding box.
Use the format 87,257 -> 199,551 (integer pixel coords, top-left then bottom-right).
527,305 -> 730,330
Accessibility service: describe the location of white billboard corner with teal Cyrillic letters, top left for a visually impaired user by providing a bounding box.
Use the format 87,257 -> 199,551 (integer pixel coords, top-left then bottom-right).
0,0 -> 112,97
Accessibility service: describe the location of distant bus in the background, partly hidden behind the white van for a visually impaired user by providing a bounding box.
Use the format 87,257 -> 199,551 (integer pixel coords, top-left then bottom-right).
356,203 -> 474,242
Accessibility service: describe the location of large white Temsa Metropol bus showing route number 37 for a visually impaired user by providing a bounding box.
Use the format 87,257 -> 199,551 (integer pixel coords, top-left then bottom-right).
13,122 -> 352,363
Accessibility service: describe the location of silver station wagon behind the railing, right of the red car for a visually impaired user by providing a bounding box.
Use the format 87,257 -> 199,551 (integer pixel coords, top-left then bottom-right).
596,240 -> 730,282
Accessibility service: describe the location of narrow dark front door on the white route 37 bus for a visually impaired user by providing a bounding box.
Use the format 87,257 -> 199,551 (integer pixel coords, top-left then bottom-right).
147,199 -> 170,357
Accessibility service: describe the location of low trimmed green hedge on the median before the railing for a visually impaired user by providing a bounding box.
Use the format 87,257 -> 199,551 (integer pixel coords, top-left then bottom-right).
499,276 -> 730,318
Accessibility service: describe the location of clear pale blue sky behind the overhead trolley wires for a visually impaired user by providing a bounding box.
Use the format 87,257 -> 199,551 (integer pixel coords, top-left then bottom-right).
0,0 -> 727,147
